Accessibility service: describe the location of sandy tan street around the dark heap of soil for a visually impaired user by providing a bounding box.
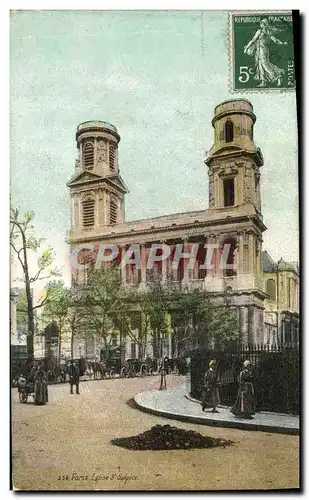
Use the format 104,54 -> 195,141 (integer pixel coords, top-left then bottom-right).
12,376 -> 299,490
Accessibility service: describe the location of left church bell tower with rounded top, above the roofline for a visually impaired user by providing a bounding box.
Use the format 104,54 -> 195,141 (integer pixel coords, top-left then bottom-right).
67,121 -> 128,233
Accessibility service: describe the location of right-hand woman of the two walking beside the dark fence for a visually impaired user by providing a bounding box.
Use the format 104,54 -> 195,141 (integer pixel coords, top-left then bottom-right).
231,360 -> 255,418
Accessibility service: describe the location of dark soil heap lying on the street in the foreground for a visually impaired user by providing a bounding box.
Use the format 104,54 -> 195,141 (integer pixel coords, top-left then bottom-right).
111,425 -> 233,450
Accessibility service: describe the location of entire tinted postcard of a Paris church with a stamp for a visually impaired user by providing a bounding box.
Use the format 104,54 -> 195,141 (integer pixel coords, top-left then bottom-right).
10,10 -> 301,492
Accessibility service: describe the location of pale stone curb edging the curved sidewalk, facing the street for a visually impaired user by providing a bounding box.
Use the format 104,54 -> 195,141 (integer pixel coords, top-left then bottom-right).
134,391 -> 299,435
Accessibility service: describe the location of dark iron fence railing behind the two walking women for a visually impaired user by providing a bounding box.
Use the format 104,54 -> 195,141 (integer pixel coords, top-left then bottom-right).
191,345 -> 300,414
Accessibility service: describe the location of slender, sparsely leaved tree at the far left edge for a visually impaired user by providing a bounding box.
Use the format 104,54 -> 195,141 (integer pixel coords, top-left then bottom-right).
10,208 -> 60,362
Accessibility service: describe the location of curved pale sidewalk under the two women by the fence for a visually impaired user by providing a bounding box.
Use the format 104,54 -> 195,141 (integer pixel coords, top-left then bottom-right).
134,385 -> 299,434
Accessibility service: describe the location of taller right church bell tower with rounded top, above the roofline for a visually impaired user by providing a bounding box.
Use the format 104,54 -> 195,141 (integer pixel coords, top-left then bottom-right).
205,99 -> 263,214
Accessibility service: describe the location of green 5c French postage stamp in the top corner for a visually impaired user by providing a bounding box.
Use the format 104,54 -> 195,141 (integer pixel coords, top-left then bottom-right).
229,11 -> 295,92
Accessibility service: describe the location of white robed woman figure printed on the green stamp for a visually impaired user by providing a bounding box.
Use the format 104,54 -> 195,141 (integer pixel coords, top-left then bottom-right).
244,19 -> 287,87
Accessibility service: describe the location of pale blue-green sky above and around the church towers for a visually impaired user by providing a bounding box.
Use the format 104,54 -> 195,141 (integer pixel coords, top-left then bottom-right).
11,11 -> 298,282
